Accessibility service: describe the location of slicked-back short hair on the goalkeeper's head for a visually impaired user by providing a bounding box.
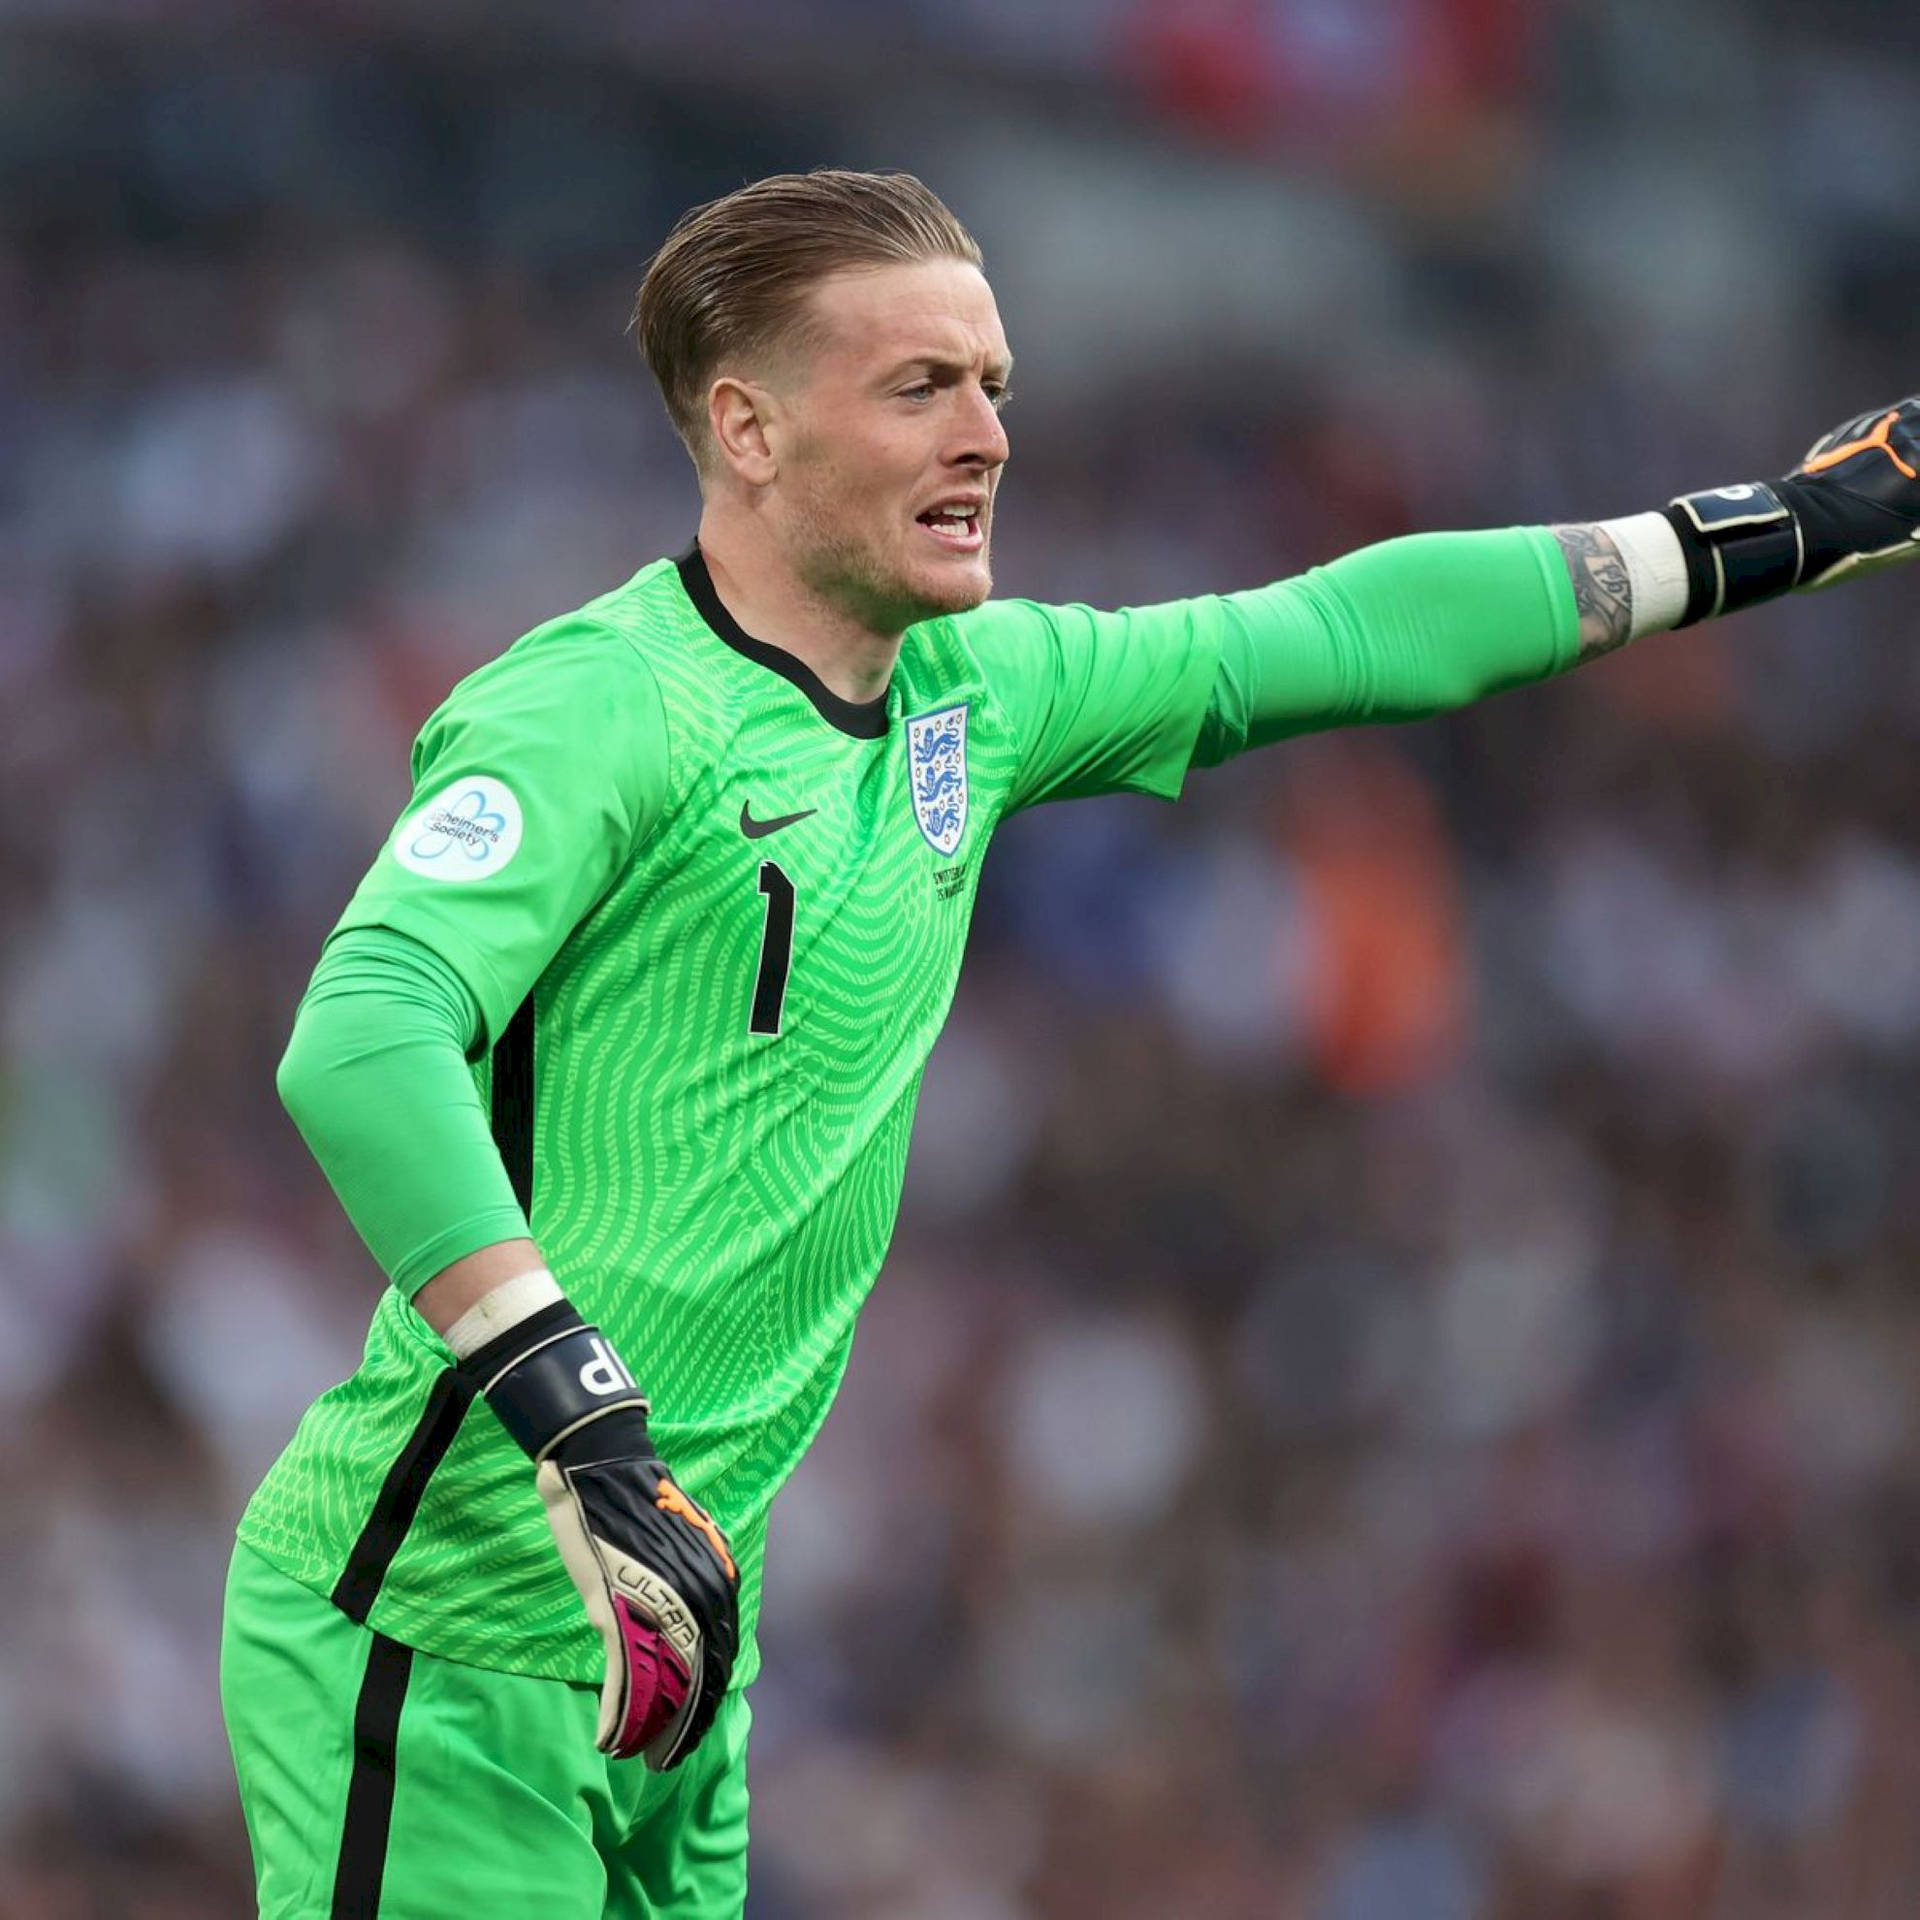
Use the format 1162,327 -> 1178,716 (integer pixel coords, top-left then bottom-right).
630,167 -> 981,465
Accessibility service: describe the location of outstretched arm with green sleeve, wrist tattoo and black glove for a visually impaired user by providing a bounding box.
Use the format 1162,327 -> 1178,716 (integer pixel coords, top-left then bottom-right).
940,397 -> 1920,810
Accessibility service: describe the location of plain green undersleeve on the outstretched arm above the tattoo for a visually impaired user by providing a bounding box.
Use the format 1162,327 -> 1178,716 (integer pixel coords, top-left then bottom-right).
1192,526 -> 1580,766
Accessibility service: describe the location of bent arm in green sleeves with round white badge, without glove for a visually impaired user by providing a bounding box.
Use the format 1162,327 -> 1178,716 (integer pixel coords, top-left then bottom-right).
278,614 -> 666,1350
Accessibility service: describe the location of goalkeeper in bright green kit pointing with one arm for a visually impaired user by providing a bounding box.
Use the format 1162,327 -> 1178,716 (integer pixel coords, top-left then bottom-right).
221,173 -> 1920,1920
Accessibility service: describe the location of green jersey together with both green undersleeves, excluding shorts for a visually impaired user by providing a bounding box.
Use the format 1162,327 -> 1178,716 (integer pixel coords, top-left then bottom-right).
242,528 -> 1576,1686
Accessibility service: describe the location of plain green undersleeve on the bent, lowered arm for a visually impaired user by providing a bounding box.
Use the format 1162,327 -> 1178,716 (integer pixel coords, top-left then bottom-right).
276,927 -> 528,1294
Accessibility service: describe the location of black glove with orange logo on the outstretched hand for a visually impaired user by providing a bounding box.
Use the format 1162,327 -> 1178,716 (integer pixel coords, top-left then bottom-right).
1667,396 -> 1920,626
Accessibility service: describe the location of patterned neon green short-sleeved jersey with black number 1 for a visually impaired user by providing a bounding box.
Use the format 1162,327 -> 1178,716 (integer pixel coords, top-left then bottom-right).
240,549 -> 1231,1684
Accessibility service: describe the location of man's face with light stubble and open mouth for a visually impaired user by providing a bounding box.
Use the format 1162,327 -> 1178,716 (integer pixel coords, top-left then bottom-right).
766,259 -> 1012,634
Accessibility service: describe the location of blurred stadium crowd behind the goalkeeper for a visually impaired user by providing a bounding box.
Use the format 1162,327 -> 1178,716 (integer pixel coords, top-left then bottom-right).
0,0 -> 1920,1920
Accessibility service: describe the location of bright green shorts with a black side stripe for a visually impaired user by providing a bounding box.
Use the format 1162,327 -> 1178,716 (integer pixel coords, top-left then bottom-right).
221,1546 -> 751,1920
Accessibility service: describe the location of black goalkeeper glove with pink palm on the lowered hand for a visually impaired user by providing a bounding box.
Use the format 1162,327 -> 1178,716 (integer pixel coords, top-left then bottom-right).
461,1300 -> 739,1772
